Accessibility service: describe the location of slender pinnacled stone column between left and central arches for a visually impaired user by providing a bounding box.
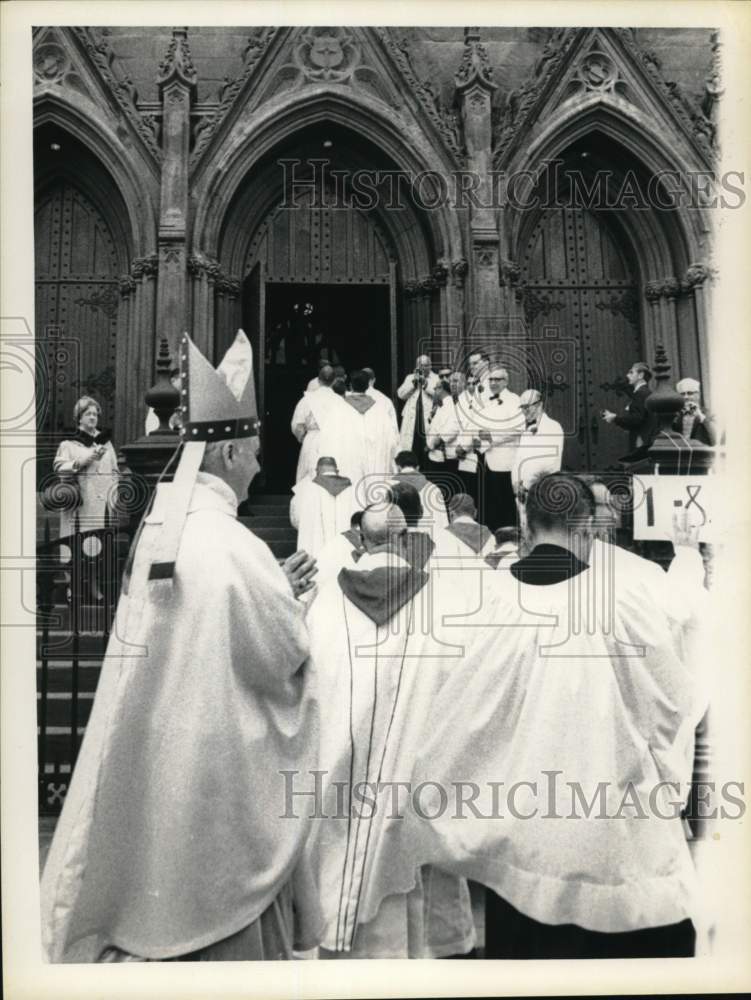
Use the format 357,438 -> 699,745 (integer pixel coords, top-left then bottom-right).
157,28 -> 197,353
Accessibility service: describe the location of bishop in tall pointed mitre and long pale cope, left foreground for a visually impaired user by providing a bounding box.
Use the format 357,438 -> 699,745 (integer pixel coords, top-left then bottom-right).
41,334 -> 320,962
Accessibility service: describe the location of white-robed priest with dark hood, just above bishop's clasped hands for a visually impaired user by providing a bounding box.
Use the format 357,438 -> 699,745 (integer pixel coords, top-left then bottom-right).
289,455 -> 355,559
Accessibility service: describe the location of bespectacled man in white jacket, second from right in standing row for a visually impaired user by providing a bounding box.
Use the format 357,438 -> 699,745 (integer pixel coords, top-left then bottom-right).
477,367 -> 524,531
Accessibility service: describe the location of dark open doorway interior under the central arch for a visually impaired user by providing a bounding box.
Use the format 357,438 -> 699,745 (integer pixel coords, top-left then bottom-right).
252,282 -> 392,493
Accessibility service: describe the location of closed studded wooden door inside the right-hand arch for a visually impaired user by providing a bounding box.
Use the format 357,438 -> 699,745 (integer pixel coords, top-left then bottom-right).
521,208 -> 643,472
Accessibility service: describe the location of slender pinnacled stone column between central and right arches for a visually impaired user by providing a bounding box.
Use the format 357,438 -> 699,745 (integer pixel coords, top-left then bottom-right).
455,28 -> 501,318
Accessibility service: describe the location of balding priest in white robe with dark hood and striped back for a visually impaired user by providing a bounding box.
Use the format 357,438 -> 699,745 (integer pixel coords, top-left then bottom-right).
307,508 -> 475,959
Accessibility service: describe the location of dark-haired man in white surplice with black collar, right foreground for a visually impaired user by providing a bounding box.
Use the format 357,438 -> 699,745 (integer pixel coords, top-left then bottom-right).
384,473 -> 701,959
